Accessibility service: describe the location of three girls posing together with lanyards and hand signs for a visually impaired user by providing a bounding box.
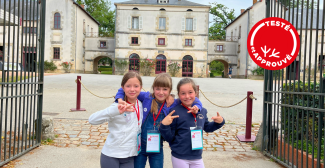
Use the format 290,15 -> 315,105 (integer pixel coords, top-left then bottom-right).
89,72 -> 224,168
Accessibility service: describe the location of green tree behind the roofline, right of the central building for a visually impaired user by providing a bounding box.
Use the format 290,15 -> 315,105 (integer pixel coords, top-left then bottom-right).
209,2 -> 236,40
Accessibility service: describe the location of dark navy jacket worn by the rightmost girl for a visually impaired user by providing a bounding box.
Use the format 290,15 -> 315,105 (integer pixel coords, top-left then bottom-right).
159,105 -> 225,160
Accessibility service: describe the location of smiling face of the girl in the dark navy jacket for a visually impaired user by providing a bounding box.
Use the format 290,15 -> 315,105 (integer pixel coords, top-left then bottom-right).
178,83 -> 195,107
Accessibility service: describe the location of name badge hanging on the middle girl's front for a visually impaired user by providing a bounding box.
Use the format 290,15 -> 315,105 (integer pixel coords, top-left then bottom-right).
146,130 -> 160,153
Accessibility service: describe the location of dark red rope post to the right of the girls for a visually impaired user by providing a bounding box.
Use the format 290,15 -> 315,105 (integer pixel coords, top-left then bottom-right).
237,91 -> 256,142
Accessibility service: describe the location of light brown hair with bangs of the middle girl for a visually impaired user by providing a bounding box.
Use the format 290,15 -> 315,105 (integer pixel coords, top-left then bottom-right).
150,73 -> 173,114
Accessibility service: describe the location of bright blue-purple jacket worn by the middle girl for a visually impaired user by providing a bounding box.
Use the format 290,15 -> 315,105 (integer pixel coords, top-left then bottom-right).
115,88 -> 202,124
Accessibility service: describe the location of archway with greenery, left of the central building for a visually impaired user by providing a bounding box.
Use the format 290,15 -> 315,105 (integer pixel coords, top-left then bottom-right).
93,56 -> 113,74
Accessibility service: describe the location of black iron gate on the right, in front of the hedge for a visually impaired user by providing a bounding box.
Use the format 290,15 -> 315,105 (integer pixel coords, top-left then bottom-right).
263,0 -> 325,168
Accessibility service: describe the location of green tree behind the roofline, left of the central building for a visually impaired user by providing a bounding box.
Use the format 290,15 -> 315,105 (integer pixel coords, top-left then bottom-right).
77,0 -> 115,37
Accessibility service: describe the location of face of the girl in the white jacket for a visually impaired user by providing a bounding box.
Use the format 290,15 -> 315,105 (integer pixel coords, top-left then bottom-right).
122,77 -> 142,101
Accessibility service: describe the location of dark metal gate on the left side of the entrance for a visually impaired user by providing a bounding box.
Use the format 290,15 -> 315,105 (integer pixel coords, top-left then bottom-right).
0,0 -> 46,166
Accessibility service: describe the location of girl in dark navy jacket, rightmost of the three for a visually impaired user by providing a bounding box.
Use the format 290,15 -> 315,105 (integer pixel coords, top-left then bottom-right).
159,78 -> 225,168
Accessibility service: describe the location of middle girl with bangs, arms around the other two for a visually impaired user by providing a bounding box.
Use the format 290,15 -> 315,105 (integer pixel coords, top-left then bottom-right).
115,73 -> 202,168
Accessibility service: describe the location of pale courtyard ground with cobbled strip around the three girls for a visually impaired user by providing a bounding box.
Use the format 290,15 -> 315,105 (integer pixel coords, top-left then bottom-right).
1,74 -> 280,168
